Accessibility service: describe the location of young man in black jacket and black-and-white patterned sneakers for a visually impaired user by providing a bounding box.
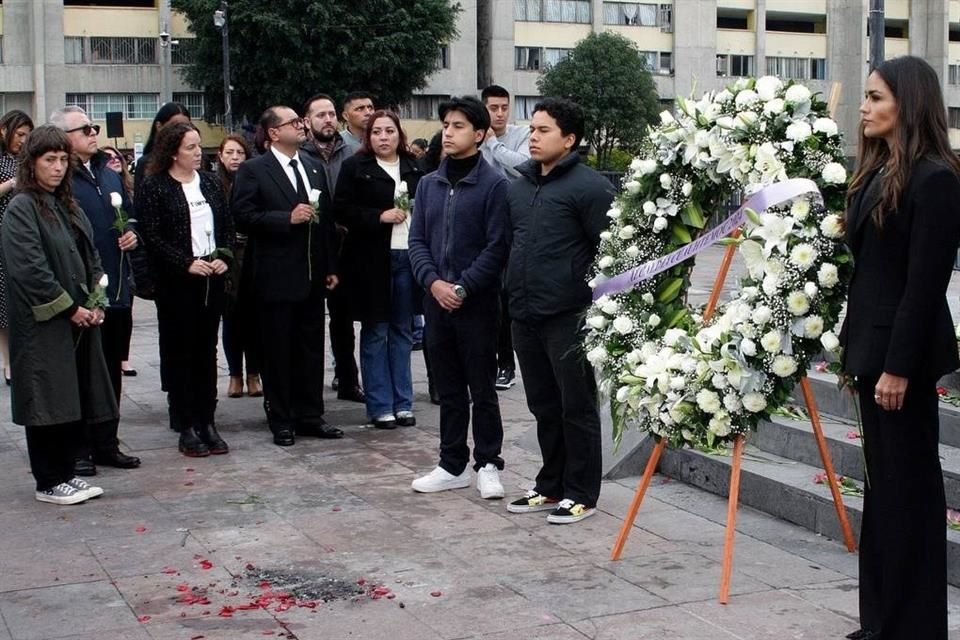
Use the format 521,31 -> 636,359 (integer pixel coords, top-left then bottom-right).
506,98 -> 613,524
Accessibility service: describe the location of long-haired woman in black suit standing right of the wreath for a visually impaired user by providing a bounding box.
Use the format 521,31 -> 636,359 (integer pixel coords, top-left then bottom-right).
841,57 -> 960,640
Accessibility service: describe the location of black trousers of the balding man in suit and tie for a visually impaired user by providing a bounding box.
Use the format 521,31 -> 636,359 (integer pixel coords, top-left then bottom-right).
259,282 -> 324,431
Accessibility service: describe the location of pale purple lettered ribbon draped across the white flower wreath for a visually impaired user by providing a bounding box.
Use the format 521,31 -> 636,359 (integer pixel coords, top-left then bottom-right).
593,178 -> 819,300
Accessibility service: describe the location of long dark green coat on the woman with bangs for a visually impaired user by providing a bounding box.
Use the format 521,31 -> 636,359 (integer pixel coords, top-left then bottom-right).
0,193 -> 117,426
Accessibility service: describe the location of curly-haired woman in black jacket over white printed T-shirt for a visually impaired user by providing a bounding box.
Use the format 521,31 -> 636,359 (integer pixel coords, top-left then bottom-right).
137,123 -> 234,457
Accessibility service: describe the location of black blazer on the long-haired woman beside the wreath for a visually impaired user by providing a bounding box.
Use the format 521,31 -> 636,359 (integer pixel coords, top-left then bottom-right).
840,158 -> 960,380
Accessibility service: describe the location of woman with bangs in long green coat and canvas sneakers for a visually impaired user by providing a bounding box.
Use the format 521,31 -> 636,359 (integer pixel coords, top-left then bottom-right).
2,125 -> 117,504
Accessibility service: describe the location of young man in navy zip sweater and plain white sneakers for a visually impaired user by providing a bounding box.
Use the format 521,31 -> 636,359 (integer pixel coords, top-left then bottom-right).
409,97 -> 508,498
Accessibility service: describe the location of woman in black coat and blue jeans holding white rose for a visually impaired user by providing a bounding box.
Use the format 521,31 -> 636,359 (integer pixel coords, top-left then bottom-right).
334,111 -> 422,429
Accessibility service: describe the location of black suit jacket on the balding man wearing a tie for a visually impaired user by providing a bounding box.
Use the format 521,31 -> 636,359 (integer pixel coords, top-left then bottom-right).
231,151 -> 337,302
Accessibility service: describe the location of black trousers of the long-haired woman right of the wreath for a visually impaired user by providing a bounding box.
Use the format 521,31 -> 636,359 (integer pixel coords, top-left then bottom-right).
857,377 -> 947,640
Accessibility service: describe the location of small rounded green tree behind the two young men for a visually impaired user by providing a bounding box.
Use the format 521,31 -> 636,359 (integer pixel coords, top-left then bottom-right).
537,32 -> 661,168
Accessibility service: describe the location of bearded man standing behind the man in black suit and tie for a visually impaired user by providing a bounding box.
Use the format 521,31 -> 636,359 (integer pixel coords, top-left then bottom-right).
300,93 -> 366,402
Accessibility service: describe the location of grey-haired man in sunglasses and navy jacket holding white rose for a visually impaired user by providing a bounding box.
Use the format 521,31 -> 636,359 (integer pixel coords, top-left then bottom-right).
50,106 -> 140,476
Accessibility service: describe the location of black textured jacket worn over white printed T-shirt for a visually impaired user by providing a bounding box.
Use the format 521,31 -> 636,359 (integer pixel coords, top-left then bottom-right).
137,171 -> 236,282
